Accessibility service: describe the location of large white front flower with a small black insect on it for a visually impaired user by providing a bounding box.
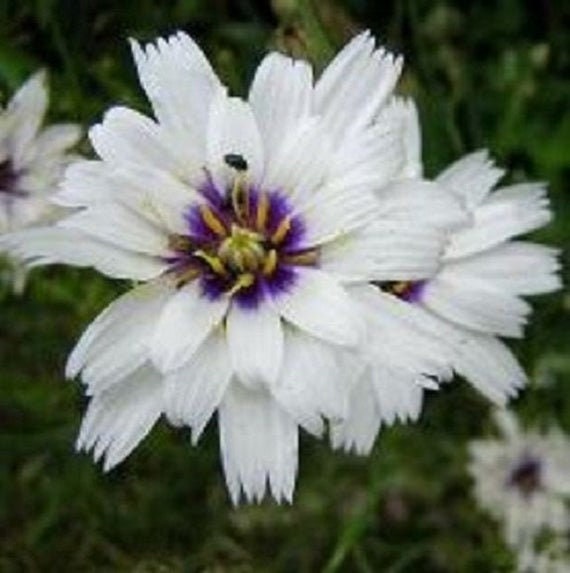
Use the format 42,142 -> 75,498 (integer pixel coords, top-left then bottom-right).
1,33 -> 452,501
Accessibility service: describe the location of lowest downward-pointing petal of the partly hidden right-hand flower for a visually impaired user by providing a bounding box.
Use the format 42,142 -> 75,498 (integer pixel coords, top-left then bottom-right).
330,376 -> 381,455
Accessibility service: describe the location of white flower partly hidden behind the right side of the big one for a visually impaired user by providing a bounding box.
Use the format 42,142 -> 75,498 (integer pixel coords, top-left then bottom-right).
333,98 -> 560,453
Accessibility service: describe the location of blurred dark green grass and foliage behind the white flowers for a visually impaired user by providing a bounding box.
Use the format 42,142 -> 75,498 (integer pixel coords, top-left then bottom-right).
0,0 -> 570,573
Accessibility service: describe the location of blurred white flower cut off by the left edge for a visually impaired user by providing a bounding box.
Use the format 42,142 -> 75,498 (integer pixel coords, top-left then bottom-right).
0,72 -> 81,291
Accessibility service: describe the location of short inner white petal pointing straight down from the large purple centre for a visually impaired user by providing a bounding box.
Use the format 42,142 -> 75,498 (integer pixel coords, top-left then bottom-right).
226,303 -> 283,388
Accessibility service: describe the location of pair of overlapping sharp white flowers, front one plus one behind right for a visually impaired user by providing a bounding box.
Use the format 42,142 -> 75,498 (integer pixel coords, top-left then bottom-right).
1,33 -> 559,502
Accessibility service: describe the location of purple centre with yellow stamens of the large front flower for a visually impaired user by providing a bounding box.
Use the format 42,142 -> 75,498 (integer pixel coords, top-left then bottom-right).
167,171 -> 319,308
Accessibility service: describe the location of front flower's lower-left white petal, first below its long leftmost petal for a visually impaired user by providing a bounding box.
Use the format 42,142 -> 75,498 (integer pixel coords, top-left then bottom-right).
65,283 -> 169,394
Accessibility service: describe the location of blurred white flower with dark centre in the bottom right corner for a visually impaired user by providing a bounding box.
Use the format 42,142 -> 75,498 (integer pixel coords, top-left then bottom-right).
469,410 -> 570,572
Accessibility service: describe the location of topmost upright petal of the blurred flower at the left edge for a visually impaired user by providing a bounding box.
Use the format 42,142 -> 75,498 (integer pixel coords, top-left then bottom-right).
3,71 -> 48,168
